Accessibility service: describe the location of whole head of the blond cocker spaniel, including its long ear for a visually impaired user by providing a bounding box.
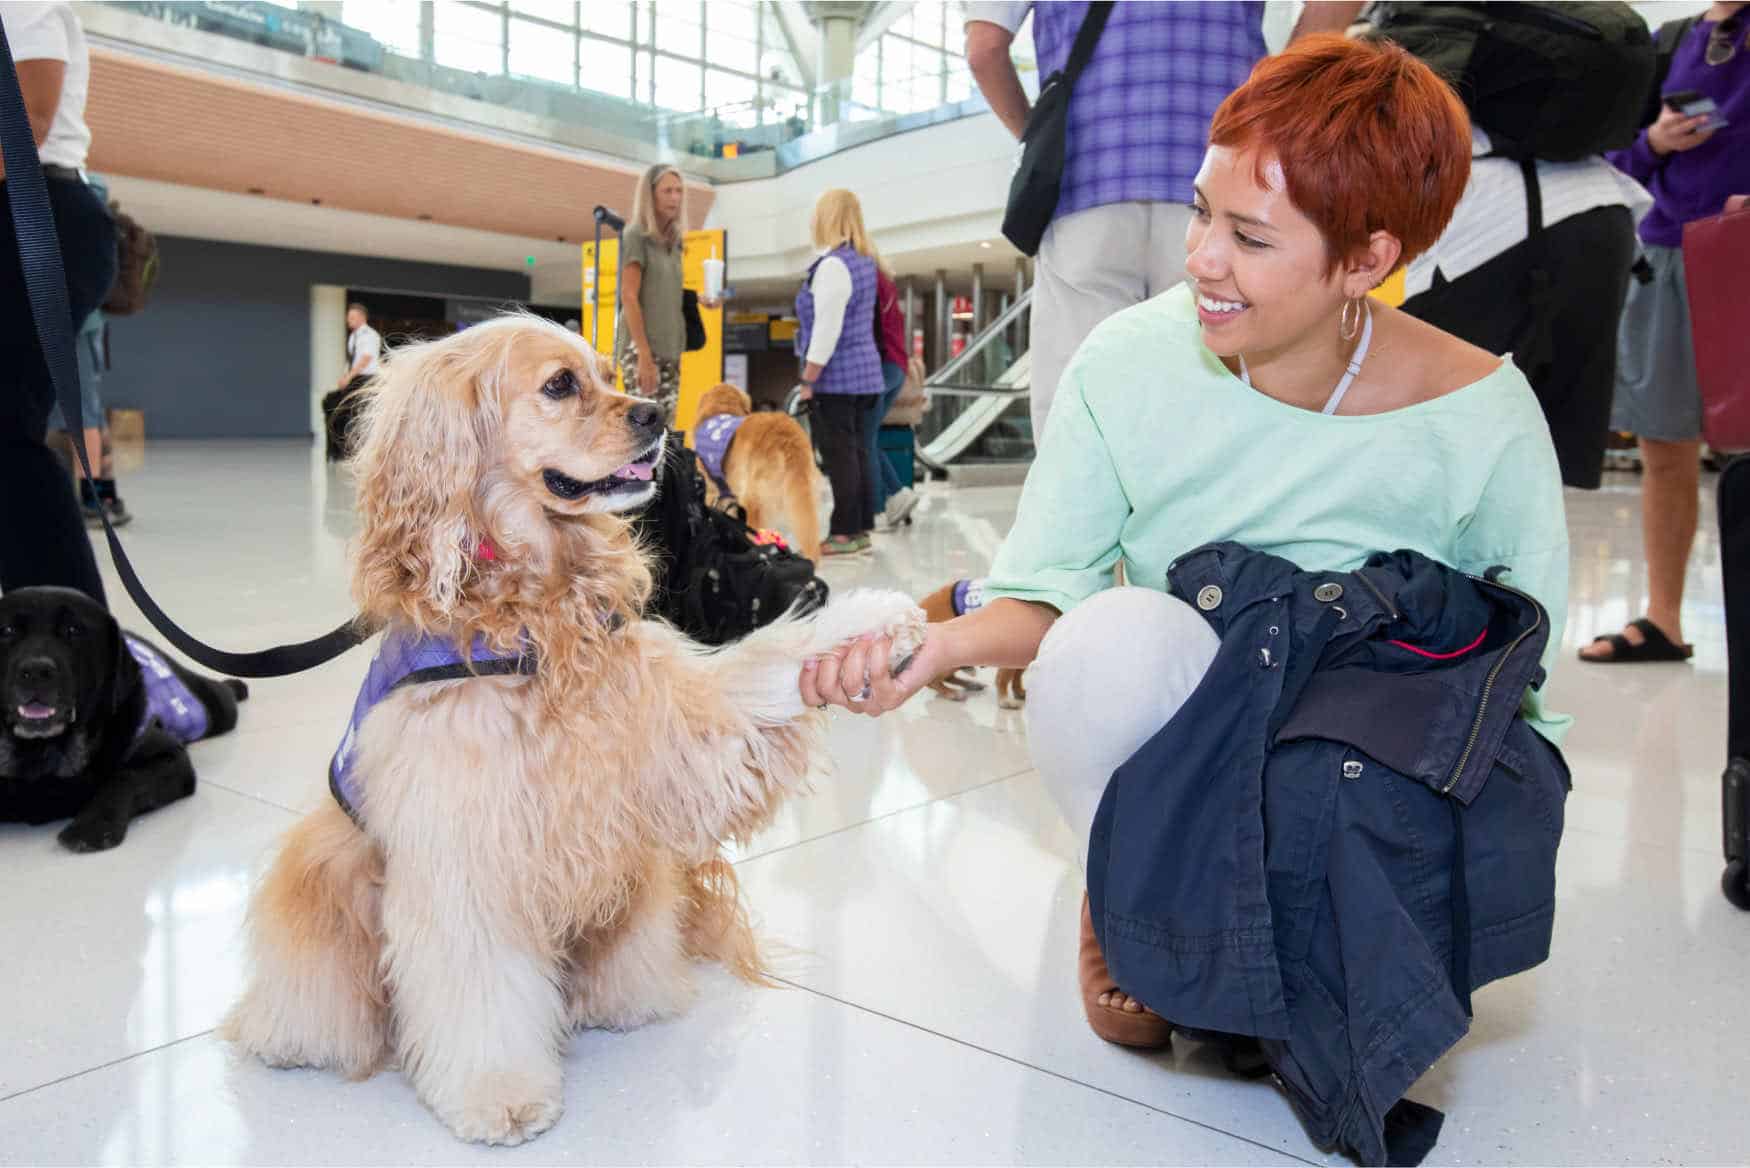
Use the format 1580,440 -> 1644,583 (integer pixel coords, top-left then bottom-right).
354,315 -> 665,623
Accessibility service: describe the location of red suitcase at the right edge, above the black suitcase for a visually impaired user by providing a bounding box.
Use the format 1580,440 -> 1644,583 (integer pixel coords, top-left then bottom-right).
1684,200 -> 1750,450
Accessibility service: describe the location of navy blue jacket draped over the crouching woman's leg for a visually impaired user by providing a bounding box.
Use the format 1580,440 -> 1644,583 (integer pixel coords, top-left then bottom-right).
1089,543 -> 1568,1164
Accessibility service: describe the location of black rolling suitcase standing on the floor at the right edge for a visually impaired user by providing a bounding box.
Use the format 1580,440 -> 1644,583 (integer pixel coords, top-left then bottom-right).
1720,455 -> 1750,909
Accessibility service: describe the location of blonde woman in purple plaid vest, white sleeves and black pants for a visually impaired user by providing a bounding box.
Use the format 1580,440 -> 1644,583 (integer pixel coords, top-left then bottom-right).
796,191 -> 886,555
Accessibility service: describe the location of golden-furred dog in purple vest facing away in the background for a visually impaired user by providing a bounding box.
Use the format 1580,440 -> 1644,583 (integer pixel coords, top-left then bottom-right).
691,385 -> 831,560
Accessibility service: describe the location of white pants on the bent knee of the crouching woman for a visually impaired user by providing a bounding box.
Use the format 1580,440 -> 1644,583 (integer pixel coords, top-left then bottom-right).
1026,588 -> 1222,865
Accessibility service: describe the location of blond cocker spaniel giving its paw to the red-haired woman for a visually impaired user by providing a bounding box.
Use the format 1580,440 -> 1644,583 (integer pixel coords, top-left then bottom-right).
222,317 -> 922,1143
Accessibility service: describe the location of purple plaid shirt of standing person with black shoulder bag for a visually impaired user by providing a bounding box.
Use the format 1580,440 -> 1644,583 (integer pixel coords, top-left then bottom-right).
1033,0 -> 1265,215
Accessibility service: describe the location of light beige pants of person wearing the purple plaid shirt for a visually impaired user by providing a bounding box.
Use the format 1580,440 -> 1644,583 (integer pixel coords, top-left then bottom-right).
1029,203 -> 1192,447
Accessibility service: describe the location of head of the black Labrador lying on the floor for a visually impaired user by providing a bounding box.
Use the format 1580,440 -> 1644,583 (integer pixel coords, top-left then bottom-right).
0,588 -> 123,742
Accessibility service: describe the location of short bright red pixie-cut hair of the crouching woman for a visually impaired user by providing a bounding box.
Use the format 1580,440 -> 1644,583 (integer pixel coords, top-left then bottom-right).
1209,33 -> 1470,271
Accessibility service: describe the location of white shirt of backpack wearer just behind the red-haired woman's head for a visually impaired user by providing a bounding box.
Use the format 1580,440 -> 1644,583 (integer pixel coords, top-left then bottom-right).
1404,126 -> 1652,298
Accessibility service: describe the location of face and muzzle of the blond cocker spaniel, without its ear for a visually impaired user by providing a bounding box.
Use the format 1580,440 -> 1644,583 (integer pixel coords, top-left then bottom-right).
497,339 -> 665,515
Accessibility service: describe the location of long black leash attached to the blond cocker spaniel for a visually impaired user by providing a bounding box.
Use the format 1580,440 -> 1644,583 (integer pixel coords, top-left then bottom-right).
0,28 -> 364,678
